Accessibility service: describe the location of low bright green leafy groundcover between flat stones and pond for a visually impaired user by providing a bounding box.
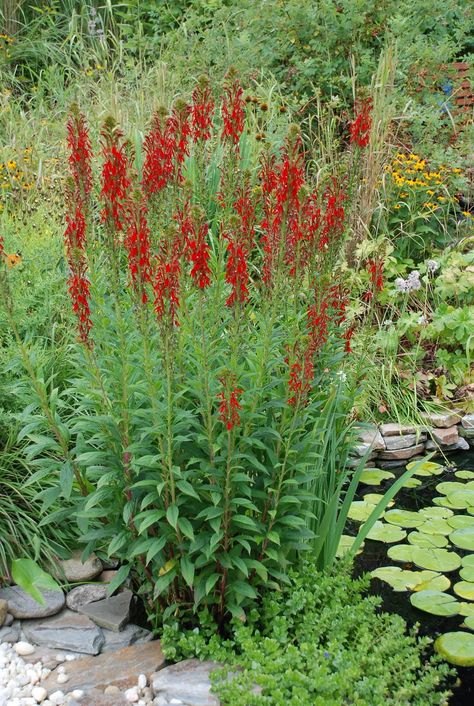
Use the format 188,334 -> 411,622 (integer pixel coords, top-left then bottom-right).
162,564 -> 450,706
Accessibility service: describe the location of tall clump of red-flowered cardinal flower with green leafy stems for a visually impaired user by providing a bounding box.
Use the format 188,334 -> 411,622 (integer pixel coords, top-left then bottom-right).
1,72 -> 367,624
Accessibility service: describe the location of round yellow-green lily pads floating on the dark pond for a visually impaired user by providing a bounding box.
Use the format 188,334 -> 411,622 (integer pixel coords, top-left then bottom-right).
352,461 -> 474,667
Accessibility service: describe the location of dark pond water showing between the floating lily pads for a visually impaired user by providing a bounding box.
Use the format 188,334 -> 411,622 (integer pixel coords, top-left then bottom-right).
356,450 -> 474,706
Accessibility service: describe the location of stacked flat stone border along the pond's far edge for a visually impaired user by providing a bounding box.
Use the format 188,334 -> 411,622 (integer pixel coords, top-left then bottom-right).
353,411 -> 474,468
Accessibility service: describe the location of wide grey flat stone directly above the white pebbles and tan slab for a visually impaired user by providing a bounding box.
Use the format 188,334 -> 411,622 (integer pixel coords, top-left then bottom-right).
23,608 -> 105,655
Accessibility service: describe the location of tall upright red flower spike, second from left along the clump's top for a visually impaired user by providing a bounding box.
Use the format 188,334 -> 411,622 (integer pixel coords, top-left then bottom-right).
100,119 -> 130,231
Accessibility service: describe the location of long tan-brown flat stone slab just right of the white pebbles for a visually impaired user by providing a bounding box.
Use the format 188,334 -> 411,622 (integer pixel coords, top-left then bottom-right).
43,640 -> 165,688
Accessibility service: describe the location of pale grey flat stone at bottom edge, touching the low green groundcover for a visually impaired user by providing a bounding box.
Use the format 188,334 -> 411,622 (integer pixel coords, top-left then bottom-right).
150,659 -> 220,706
